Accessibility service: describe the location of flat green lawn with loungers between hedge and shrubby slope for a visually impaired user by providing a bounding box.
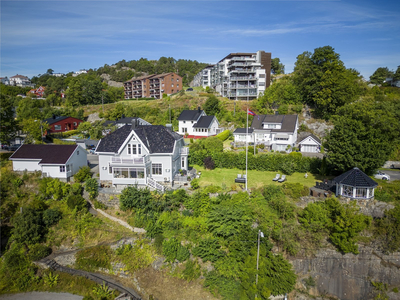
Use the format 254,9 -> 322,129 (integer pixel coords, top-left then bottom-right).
194,166 -> 319,189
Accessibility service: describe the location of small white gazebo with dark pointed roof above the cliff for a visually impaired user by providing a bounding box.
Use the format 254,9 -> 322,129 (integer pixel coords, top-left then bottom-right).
334,167 -> 378,199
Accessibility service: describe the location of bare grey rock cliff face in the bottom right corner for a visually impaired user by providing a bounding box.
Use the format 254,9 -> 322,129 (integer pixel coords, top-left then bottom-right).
291,246 -> 400,300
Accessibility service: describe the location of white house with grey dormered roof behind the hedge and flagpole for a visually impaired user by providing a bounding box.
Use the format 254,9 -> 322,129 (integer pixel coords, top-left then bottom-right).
233,115 -> 298,152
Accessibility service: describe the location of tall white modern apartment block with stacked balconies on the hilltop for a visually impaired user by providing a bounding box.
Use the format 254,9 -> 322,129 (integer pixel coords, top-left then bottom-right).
193,51 -> 271,100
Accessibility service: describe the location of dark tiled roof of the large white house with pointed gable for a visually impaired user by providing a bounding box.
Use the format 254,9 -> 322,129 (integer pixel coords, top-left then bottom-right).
96,125 -> 182,153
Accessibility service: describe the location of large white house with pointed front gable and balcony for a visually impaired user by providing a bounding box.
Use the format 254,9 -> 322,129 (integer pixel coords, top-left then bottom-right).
95,120 -> 189,190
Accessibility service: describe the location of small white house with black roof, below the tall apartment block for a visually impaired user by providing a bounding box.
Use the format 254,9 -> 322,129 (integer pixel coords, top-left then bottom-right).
178,107 -> 219,138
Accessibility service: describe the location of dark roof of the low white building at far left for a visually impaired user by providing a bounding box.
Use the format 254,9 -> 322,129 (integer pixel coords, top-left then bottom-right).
10,144 -> 79,164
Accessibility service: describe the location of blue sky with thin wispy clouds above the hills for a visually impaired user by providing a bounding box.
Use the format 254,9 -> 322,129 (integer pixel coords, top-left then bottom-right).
0,0 -> 400,79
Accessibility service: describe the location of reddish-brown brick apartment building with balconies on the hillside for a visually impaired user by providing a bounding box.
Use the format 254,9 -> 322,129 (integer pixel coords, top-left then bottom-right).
124,72 -> 183,99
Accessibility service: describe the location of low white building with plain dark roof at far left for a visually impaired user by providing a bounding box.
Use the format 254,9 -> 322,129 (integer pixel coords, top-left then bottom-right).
10,144 -> 87,181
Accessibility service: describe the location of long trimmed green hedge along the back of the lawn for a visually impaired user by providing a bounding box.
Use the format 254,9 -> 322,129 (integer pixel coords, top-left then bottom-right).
189,150 -> 321,175
